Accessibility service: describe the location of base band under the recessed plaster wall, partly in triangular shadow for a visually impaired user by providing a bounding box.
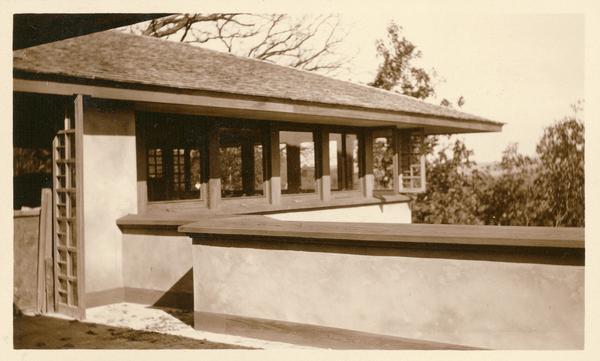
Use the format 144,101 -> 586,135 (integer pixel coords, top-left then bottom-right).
85,287 -> 194,310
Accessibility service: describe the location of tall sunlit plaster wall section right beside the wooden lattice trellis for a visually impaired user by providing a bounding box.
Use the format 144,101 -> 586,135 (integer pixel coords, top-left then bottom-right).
83,102 -> 137,293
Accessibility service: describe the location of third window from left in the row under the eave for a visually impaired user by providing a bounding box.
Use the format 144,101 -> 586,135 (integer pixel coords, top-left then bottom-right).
279,131 -> 315,194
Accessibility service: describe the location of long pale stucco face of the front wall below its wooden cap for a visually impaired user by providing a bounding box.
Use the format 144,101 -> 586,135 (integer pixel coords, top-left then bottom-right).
193,245 -> 584,349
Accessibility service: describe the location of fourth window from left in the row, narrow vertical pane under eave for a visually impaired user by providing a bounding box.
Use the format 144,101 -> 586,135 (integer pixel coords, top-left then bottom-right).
329,133 -> 359,191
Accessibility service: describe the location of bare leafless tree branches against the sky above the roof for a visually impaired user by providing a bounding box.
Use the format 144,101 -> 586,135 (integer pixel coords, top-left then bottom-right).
130,13 -> 349,73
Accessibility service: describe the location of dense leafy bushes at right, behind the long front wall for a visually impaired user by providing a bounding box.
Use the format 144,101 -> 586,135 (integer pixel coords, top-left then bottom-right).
411,113 -> 585,227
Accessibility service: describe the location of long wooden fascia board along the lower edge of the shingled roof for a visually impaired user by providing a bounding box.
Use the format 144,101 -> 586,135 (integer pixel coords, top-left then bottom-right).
13,78 -> 502,134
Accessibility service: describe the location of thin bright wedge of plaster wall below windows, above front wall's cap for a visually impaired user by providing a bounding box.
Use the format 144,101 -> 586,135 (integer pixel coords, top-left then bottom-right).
267,203 -> 411,223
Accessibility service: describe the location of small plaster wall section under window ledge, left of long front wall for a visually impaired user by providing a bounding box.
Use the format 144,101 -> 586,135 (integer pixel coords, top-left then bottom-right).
123,234 -> 193,293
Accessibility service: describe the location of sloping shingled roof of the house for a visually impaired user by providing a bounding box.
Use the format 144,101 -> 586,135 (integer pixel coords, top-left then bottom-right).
13,30 -> 500,124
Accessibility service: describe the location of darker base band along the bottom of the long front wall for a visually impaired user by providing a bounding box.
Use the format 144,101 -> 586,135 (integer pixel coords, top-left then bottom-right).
194,311 -> 473,350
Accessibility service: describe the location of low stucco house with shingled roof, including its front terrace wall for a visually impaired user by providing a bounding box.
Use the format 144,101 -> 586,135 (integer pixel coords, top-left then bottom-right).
13,31 -> 583,348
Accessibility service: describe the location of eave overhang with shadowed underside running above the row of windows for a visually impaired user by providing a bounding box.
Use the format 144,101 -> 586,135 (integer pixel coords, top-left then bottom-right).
13,78 -> 503,134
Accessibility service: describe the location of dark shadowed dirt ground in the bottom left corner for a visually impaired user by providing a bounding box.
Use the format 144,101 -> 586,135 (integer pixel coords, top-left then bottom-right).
13,315 -> 253,349
